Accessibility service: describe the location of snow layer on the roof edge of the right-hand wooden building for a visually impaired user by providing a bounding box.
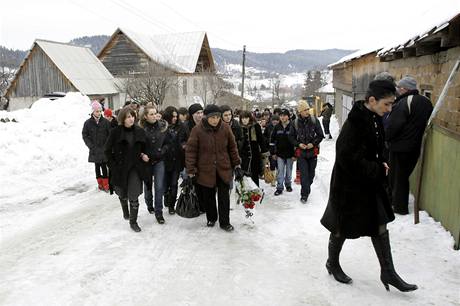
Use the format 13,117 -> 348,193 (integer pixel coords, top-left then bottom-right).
377,11 -> 460,56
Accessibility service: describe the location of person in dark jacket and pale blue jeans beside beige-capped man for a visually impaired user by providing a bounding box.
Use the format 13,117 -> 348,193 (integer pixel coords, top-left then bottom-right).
270,109 -> 294,196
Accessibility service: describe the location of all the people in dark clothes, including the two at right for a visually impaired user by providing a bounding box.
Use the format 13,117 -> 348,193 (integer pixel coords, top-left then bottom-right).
82,73 -> 433,291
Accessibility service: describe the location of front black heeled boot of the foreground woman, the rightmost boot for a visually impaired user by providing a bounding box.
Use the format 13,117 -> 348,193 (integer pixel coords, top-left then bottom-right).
372,231 -> 418,292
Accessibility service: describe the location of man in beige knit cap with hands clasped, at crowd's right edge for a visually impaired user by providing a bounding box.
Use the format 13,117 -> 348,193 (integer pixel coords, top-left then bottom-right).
289,100 -> 324,204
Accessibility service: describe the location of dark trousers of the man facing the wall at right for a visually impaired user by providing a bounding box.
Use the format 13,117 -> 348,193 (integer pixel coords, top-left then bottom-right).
389,151 -> 419,214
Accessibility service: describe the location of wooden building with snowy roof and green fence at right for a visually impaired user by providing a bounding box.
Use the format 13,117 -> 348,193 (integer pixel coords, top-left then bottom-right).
329,12 -> 460,248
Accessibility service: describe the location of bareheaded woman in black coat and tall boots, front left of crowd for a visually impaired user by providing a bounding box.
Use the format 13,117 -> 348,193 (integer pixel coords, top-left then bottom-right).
105,106 -> 149,232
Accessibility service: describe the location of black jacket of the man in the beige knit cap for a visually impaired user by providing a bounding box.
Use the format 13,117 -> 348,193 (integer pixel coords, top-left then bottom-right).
289,115 -> 324,159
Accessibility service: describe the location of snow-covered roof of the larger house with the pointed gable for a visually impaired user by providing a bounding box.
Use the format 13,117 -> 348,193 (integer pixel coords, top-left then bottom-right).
109,28 -> 212,73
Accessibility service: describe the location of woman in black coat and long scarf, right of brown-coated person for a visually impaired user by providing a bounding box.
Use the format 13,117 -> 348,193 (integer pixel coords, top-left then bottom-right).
238,111 -> 269,186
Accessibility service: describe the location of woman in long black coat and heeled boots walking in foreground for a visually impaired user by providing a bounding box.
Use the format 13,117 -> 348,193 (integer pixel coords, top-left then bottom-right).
321,80 -> 417,291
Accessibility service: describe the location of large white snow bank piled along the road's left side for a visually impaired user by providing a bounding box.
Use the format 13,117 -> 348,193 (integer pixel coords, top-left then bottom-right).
0,93 -> 92,211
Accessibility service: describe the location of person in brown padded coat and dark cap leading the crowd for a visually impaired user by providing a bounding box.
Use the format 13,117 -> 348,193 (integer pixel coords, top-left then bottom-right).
185,104 -> 243,231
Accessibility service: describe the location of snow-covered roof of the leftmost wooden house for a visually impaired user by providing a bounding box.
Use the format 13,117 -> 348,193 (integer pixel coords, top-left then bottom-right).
35,39 -> 118,95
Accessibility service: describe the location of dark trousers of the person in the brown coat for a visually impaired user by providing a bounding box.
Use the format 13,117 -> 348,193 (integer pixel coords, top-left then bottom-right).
200,175 -> 230,226
